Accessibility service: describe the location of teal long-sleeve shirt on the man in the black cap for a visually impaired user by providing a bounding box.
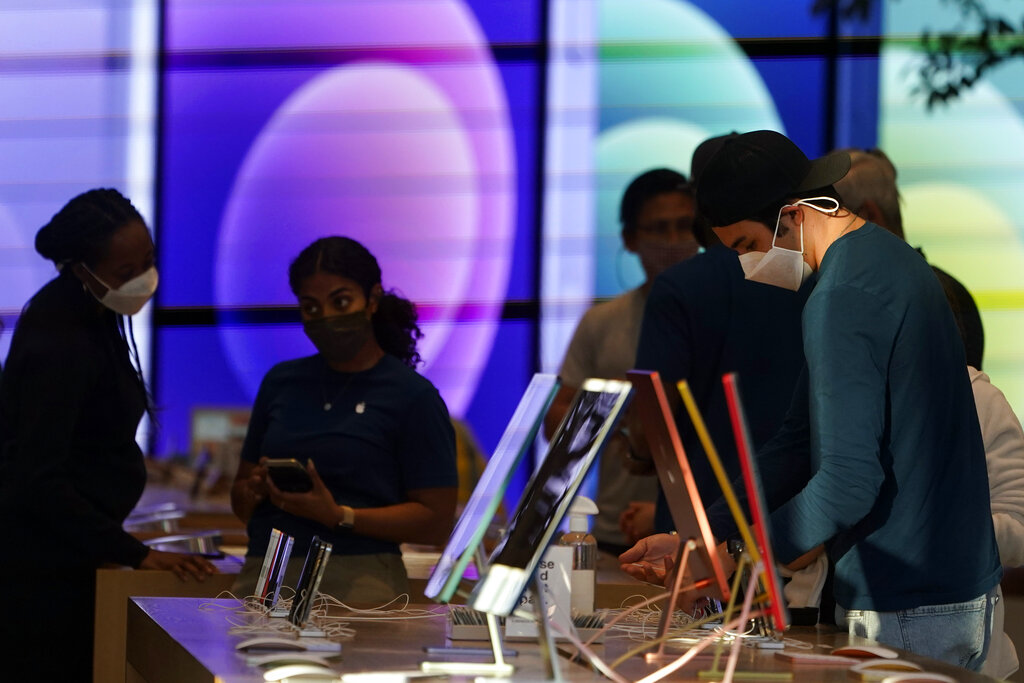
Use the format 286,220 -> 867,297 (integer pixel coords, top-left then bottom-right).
716,223 -> 1001,611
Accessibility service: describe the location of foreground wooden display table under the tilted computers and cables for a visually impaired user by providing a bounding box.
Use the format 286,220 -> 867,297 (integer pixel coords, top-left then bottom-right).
127,598 -> 992,683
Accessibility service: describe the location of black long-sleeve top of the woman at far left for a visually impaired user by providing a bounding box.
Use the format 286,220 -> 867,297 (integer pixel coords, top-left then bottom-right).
0,271 -> 147,567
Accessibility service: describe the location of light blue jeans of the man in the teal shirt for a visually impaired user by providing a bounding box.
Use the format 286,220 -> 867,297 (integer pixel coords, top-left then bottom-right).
836,589 -> 995,671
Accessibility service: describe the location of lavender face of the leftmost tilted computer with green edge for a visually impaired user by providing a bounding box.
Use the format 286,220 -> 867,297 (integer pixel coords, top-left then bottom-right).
424,373 -> 558,602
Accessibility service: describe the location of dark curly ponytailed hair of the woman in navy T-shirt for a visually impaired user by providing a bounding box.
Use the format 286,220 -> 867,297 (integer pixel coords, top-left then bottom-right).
288,237 -> 423,368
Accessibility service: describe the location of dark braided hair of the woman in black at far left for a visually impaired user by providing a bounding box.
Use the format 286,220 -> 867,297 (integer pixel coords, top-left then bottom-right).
36,188 -> 145,268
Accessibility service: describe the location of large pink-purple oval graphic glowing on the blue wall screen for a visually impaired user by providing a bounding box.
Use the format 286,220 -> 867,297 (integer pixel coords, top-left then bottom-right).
169,2 -> 516,414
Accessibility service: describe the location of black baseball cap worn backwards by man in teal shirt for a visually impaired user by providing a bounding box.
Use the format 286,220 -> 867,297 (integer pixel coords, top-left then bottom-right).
697,130 -> 850,227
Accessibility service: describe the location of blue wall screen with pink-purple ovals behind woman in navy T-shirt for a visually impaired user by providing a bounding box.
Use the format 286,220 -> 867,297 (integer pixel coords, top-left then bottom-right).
158,0 -> 543,464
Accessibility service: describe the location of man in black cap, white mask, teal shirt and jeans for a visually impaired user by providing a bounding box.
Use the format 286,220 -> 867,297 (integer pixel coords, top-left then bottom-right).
697,131 -> 1001,670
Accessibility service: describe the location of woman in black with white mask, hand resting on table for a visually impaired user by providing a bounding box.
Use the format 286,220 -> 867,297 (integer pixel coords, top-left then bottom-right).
0,189 -> 214,681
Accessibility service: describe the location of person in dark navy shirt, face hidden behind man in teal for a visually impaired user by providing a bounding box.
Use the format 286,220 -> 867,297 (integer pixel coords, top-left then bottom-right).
623,133 -> 811,548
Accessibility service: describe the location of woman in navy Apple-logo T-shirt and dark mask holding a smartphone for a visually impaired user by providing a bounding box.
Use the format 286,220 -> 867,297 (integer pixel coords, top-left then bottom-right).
231,237 -> 458,602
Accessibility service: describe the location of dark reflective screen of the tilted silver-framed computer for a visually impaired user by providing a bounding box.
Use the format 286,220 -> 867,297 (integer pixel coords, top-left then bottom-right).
490,380 -> 630,570
